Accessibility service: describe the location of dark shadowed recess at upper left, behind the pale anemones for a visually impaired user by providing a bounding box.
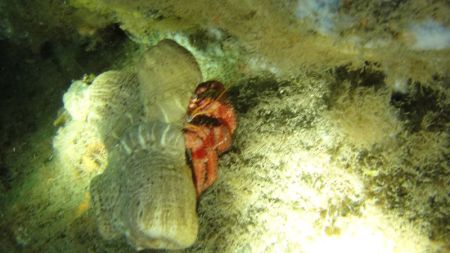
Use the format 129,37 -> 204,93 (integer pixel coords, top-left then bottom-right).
0,24 -> 134,188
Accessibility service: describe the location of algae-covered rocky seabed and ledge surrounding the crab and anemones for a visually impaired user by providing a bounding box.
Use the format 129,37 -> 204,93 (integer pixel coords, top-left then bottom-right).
0,0 -> 450,252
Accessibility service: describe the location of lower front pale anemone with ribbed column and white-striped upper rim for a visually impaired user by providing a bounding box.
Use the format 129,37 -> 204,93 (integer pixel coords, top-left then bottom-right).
91,121 -> 198,249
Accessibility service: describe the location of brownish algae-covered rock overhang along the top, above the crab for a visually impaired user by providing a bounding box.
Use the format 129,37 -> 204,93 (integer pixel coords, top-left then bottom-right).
65,0 -> 449,84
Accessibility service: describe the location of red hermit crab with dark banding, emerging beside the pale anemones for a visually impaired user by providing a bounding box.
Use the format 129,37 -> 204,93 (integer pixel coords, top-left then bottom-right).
183,81 -> 237,198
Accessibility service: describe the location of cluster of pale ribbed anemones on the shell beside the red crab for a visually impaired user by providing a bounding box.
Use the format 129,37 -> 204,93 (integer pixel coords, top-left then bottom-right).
88,40 -> 201,250
